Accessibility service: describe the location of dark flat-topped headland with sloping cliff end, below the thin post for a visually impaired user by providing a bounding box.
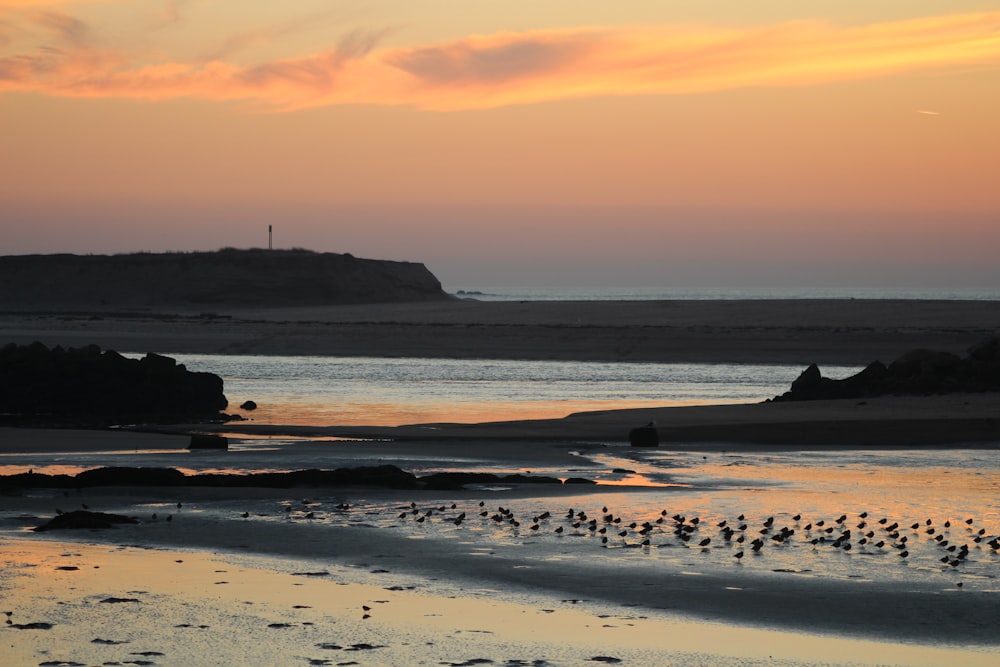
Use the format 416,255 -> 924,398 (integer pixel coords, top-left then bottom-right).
0,249 -> 448,310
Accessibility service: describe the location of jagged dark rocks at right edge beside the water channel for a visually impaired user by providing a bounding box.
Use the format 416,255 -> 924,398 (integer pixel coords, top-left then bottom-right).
773,337 -> 1000,401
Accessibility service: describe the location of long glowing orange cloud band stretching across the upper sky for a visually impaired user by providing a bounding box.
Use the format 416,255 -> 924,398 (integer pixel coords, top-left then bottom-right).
0,12 -> 1000,111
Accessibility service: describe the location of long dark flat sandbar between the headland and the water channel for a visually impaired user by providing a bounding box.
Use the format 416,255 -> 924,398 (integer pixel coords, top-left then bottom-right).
0,299 -> 1000,366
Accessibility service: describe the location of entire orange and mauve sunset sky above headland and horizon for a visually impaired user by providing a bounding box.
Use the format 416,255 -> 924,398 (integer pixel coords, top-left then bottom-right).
0,0 -> 1000,289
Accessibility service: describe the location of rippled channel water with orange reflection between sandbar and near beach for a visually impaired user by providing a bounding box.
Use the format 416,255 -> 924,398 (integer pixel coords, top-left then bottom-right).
152,354 -> 861,426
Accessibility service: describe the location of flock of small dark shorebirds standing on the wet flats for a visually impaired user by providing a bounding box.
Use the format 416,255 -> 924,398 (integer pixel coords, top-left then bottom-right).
384,501 -> 1000,568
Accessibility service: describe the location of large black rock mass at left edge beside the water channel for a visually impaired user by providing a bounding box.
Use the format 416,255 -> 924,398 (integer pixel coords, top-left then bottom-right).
0,342 -> 228,425
